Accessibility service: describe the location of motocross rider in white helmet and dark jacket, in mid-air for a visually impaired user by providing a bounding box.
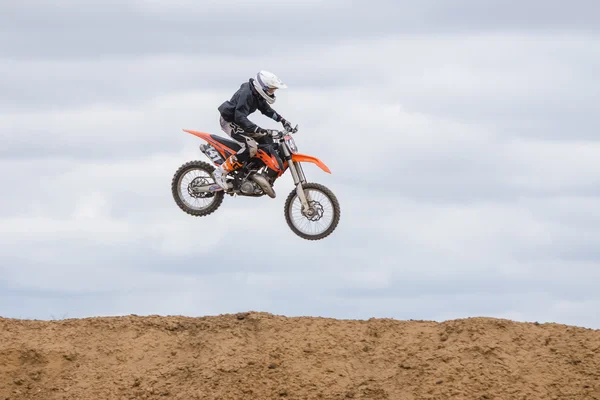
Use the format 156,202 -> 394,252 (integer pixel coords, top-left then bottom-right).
213,71 -> 292,190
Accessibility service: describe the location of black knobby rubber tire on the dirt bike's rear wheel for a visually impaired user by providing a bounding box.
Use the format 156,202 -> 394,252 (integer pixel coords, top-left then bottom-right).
171,161 -> 225,217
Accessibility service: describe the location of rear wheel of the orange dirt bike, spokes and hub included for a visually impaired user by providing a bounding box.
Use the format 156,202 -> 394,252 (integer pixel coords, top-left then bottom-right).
171,161 -> 225,217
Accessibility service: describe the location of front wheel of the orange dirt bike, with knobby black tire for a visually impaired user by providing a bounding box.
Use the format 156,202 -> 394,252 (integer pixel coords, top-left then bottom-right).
284,183 -> 341,240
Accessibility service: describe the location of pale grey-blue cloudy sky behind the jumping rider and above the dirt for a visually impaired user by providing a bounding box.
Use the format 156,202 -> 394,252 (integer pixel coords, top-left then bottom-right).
0,0 -> 600,328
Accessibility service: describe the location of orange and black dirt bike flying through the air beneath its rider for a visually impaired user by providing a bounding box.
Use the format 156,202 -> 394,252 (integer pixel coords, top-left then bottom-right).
171,125 -> 340,240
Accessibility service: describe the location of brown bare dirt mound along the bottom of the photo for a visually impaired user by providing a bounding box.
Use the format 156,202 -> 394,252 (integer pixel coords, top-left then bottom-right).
0,312 -> 600,400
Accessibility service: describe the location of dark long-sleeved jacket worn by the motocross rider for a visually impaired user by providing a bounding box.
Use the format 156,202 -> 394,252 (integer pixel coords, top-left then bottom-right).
218,78 -> 282,133
